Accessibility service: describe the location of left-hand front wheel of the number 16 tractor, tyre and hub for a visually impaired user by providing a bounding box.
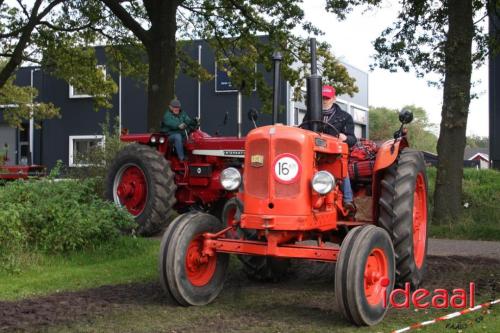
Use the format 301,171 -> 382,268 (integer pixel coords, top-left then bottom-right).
159,213 -> 229,306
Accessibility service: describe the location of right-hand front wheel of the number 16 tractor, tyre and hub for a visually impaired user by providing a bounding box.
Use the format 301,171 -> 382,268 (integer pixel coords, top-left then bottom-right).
335,225 -> 395,326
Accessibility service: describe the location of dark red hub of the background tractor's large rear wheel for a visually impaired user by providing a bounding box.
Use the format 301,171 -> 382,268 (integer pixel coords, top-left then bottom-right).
115,165 -> 148,216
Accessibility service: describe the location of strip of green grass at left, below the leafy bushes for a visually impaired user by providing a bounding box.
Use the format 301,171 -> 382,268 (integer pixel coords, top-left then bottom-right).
0,237 -> 159,300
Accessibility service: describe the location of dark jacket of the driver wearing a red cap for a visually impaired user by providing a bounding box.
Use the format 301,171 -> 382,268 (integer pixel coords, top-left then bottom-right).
303,103 -> 357,148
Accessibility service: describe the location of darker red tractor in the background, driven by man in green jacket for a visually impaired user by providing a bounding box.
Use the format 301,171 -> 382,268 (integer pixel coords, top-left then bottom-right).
106,118 -> 245,236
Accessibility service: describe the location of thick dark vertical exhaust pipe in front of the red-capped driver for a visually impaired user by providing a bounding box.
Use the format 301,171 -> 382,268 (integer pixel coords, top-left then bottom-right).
307,38 -> 323,132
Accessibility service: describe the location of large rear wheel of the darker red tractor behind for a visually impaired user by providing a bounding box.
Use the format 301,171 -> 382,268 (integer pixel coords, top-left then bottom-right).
106,144 -> 176,236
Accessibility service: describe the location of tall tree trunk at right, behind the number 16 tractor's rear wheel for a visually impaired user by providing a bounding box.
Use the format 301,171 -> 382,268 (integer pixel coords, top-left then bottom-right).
434,0 -> 474,223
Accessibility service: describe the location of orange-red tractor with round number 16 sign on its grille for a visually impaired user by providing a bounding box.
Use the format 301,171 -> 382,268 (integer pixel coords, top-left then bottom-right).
159,41 -> 427,325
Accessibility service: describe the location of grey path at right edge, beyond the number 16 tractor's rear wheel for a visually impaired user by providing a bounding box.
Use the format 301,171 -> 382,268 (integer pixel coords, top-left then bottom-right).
428,238 -> 500,260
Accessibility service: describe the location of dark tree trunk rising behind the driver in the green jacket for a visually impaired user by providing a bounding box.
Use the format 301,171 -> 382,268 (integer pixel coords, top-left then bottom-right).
146,1 -> 177,131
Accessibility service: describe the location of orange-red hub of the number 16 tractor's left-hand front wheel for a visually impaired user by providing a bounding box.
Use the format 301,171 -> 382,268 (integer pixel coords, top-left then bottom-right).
186,235 -> 217,287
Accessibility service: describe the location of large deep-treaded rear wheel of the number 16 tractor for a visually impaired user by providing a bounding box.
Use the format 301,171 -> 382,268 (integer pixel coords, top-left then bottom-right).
378,148 -> 428,289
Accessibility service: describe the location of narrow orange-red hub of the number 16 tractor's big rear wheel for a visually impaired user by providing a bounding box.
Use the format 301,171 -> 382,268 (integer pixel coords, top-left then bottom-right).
413,173 -> 427,268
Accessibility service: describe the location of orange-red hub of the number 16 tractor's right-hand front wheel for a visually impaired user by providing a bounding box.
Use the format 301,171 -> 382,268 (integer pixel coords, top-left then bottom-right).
364,248 -> 389,305
